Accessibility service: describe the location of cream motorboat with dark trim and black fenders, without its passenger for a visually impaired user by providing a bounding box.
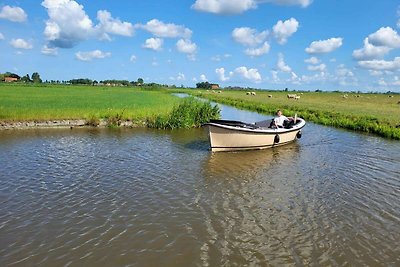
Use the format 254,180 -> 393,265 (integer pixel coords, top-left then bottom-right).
203,118 -> 306,151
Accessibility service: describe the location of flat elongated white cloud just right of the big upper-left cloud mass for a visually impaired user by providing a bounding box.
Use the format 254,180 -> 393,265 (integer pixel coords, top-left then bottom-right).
136,19 -> 192,39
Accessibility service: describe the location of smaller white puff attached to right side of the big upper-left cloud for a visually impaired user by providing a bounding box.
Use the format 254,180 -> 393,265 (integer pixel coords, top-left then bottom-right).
96,10 -> 134,39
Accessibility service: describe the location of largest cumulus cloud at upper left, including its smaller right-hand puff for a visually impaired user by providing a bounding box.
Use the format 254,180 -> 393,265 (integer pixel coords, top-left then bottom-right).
42,0 -> 133,48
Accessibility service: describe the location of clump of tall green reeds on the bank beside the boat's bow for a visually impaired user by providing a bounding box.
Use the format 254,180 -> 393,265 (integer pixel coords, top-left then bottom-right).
147,97 -> 220,129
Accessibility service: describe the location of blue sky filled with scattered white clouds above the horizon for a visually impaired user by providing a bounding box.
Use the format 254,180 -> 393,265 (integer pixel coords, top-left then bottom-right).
0,0 -> 400,92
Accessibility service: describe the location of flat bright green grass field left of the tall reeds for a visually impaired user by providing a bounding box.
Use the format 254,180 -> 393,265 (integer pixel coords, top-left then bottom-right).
0,83 -> 181,124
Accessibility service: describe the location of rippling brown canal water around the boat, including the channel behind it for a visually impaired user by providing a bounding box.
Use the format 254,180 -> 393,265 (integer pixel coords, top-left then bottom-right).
0,106 -> 400,266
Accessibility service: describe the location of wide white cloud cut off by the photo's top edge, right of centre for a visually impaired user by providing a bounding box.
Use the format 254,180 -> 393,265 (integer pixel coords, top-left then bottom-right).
192,0 -> 312,15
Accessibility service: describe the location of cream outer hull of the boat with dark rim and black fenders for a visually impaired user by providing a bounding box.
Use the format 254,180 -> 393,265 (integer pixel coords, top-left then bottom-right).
205,121 -> 305,151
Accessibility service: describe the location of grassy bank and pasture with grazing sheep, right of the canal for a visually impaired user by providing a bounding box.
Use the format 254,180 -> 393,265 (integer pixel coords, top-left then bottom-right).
189,90 -> 400,140
